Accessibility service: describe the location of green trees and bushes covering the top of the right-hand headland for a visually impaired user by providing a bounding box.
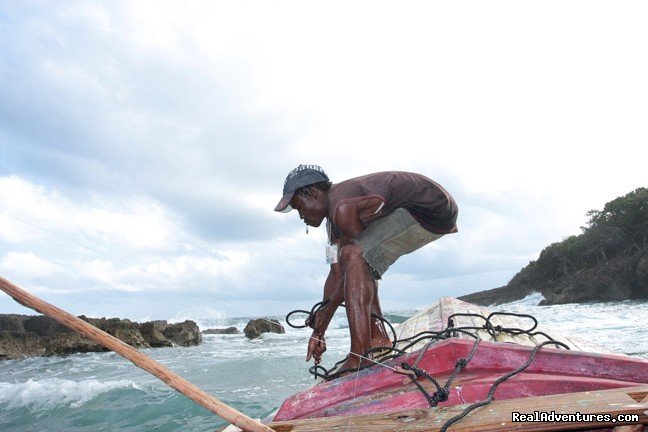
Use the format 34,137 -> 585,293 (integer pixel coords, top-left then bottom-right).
511,188 -> 648,282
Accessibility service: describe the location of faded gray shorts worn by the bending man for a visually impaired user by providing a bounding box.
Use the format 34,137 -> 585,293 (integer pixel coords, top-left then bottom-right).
354,208 -> 443,280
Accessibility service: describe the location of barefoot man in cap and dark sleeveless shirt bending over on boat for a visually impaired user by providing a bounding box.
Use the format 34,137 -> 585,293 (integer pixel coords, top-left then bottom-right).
275,165 -> 458,371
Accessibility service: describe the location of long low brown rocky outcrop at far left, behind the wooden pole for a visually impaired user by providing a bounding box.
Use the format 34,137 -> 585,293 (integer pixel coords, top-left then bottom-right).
0,314 -> 201,360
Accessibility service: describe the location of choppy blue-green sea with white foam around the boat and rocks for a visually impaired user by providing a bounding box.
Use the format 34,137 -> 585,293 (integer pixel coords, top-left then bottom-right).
0,295 -> 648,432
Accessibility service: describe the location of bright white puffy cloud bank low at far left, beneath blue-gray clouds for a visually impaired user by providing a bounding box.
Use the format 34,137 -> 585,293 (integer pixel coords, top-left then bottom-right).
0,176 -> 180,252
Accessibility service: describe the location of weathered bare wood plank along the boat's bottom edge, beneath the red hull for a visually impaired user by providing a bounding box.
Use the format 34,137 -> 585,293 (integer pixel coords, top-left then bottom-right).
269,386 -> 648,432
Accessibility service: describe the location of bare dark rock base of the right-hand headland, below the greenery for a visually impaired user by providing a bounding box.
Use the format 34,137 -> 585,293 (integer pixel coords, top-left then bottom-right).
459,249 -> 648,306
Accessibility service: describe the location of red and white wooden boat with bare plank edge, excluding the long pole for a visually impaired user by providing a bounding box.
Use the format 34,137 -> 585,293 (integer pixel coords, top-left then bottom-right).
268,297 -> 648,431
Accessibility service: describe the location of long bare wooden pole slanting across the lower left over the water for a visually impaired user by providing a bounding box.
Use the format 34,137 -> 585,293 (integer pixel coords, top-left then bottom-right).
0,277 -> 272,432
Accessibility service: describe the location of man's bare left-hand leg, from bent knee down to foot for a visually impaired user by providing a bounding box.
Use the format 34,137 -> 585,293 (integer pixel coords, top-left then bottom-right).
340,244 -> 375,369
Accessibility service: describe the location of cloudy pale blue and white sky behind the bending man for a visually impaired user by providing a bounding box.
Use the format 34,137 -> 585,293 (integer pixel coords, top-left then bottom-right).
0,0 -> 648,319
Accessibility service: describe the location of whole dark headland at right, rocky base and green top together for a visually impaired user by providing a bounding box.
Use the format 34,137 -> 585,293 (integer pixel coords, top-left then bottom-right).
459,188 -> 648,305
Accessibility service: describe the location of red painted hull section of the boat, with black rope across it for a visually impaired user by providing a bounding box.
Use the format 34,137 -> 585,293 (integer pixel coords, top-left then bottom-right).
274,338 -> 648,421
